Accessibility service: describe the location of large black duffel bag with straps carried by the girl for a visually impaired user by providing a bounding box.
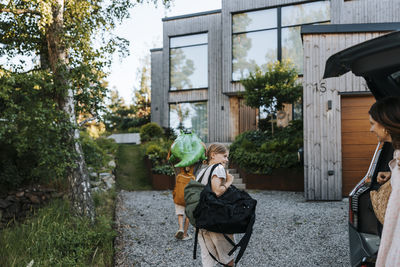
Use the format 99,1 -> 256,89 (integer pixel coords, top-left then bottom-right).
193,164 -> 257,265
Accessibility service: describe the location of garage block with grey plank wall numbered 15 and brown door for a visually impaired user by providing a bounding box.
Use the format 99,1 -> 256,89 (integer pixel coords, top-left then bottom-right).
302,24 -> 400,200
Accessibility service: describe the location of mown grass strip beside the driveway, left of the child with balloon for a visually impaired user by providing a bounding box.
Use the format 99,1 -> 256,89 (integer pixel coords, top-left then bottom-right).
116,144 -> 152,191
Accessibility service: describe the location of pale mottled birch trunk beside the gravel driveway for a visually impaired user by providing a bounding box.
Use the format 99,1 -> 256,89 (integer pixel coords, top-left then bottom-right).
46,0 -> 95,221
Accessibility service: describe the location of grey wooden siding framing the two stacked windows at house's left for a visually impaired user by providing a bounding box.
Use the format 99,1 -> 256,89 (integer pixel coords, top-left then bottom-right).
163,13 -> 231,142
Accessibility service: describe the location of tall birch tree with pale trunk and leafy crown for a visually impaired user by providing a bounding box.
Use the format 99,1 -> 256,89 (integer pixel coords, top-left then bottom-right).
0,0 -> 169,220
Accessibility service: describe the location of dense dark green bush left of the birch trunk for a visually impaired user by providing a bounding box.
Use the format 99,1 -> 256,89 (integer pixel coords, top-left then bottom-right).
0,71 -> 74,189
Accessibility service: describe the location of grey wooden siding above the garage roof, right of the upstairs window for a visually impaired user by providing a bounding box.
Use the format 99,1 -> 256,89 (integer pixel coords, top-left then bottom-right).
331,0 -> 400,24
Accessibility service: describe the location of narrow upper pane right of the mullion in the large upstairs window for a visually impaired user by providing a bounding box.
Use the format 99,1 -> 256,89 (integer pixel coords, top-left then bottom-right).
282,1 -> 330,27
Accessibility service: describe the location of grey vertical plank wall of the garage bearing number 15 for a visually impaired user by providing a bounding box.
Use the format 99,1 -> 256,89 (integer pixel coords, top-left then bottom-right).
303,33 -> 383,200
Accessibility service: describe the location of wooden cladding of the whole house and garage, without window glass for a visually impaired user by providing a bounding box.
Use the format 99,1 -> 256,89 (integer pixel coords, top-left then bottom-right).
151,0 -> 400,200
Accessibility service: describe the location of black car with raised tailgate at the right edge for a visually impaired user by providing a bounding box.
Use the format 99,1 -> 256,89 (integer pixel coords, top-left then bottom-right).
324,31 -> 400,266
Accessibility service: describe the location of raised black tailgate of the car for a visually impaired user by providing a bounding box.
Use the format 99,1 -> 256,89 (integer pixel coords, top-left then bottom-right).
324,31 -> 400,99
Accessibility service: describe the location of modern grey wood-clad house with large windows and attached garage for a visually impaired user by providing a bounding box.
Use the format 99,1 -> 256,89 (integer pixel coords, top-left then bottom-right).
151,0 -> 400,200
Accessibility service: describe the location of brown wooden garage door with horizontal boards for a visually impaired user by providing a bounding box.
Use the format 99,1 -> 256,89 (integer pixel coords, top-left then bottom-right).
341,96 -> 378,196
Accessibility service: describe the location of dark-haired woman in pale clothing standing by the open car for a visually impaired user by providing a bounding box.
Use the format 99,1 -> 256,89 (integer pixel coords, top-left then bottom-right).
369,97 -> 400,267
